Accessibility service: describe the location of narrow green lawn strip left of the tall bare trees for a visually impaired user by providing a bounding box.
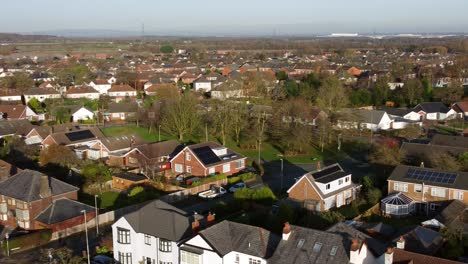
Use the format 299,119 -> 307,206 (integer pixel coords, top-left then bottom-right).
101,126 -> 174,142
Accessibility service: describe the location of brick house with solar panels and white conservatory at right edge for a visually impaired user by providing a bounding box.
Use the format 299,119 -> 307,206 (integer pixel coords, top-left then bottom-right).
381,165 -> 468,216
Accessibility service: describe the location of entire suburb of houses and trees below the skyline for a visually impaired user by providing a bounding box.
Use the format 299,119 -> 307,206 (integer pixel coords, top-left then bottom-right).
0,33 -> 468,264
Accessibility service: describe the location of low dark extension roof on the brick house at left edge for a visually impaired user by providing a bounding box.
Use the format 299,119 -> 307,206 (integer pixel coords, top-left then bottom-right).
35,198 -> 95,225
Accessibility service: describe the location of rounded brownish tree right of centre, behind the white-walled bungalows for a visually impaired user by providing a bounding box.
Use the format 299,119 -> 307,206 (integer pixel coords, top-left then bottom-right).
317,76 -> 348,115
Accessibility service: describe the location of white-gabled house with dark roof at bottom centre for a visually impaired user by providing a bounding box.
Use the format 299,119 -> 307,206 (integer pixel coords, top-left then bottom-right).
180,220 -> 280,264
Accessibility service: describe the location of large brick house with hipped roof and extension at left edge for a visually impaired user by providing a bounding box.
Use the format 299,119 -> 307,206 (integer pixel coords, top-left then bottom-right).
0,170 -> 95,231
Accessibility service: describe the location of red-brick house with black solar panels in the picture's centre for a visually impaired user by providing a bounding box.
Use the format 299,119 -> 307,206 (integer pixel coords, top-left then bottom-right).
170,142 -> 247,176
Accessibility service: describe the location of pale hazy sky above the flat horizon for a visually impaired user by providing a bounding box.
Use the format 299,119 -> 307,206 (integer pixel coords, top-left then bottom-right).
0,0 -> 468,35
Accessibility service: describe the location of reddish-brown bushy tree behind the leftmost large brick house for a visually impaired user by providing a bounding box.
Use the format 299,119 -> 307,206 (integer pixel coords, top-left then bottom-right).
39,144 -> 79,167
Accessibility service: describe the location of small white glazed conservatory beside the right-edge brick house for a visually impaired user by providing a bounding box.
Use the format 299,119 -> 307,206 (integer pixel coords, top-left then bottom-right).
380,193 -> 416,216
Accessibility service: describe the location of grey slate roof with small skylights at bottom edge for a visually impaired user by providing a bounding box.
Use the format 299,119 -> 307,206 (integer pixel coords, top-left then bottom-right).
268,225 -> 349,264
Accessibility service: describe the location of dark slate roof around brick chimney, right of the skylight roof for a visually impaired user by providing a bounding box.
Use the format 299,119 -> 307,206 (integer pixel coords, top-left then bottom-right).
327,222 -> 387,257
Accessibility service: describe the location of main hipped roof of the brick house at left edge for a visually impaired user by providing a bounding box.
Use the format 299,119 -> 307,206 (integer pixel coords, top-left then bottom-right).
0,169 -> 79,202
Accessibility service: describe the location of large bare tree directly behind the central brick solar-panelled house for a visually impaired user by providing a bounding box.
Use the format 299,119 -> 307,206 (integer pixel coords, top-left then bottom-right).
162,93 -> 200,141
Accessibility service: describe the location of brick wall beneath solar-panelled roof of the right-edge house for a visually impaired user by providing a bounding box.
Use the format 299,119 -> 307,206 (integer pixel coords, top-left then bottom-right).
388,180 -> 468,205
